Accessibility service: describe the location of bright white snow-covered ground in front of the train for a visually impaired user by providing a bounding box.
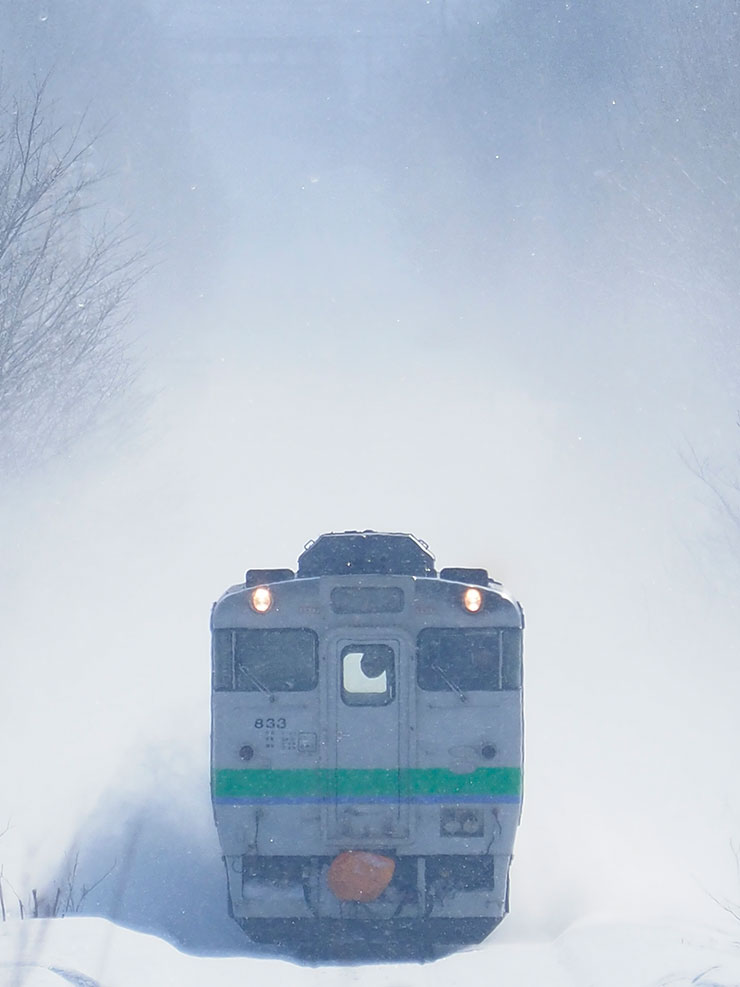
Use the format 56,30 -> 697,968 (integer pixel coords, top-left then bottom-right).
0,918 -> 740,987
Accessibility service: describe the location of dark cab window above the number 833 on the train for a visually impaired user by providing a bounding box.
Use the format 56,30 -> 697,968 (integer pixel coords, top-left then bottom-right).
213,628 -> 319,693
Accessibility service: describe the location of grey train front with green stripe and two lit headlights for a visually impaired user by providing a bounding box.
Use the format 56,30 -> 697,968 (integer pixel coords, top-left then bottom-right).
211,532 -> 523,955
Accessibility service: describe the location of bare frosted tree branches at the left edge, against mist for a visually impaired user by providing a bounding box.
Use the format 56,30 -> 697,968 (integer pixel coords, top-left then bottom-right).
0,82 -> 143,472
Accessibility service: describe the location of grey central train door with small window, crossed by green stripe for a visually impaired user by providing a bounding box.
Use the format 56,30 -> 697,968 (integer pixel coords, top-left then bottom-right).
326,630 -> 409,848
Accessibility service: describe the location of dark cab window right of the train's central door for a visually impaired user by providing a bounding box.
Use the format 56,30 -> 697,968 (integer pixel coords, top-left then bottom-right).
416,627 -> 521,693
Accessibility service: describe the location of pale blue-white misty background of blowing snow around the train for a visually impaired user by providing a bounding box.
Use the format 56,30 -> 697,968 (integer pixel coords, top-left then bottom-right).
0,0 -> 740,950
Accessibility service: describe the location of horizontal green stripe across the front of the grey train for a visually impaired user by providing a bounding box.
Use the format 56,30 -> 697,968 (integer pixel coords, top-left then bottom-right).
213,768 -> 521,799
